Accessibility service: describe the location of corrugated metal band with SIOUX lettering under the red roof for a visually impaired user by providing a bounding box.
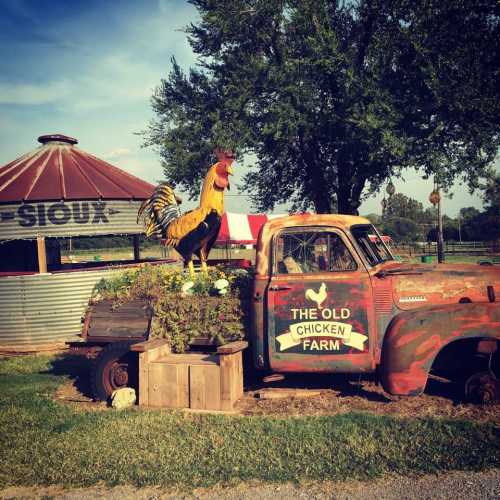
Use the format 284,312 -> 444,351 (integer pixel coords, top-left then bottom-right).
0,200 -> 144,241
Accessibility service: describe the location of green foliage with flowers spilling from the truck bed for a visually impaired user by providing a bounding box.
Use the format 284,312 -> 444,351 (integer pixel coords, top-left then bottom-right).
92,264 -> 251,352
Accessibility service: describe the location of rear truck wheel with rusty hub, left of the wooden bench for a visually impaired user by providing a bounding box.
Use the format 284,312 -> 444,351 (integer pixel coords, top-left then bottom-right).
91,342 -> 138,401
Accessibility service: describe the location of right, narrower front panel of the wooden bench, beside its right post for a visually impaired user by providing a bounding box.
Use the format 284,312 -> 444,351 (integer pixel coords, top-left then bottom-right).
189,365 -> 221,410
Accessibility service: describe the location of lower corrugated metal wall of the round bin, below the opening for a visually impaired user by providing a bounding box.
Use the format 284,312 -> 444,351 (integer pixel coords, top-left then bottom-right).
0,269 -> 116,350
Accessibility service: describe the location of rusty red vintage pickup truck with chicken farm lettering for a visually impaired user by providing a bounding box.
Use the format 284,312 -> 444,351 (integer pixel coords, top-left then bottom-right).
83,214 -> 500,402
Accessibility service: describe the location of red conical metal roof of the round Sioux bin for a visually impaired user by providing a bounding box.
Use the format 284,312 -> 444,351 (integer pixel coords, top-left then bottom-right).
0,134 -> 154,203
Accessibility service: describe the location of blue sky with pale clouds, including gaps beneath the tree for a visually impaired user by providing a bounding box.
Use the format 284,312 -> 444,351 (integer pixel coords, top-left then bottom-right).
0,0 -> 490,216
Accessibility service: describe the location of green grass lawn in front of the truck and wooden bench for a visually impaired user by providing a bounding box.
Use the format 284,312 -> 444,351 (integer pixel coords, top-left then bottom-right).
0,357 -> 500,489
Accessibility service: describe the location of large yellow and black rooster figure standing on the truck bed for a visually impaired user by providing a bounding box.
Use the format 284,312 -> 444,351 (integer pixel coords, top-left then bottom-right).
137,150 -> 234,277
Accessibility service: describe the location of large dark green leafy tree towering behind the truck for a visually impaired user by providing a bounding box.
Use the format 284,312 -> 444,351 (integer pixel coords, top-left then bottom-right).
146,0 -> 499,213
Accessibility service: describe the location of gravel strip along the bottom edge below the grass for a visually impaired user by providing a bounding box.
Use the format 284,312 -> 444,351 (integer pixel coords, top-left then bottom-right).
0,469 -> 500,500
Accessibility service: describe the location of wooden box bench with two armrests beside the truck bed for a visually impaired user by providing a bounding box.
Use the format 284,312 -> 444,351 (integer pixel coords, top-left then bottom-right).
131,339 -> 248,411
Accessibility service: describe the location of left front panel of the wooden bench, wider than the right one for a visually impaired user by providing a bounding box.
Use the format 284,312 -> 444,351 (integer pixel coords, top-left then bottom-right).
149,363 -> 189,408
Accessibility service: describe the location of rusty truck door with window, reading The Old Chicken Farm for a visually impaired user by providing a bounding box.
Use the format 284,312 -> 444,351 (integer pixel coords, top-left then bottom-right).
266,227 -> 376,373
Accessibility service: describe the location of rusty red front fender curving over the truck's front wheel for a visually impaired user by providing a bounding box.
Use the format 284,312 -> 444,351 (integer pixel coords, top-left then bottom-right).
380,303 -> 500,396
